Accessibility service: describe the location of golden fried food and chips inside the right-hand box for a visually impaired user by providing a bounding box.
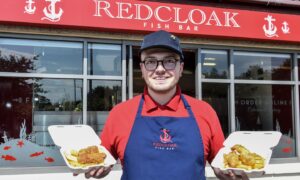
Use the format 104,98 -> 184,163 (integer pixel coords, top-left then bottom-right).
223,144 -> 265,170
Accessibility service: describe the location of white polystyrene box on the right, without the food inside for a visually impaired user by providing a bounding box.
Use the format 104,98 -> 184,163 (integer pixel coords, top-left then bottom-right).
211,131 -> 281,177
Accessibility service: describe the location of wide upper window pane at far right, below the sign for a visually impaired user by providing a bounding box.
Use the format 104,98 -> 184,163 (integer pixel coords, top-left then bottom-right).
233,52 -> 292,80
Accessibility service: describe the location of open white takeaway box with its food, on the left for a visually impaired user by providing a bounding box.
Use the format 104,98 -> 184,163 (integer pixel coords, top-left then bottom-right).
48,125 -> 116,174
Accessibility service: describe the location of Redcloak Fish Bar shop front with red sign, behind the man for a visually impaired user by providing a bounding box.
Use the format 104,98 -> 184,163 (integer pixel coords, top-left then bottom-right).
0,0 -> 300,179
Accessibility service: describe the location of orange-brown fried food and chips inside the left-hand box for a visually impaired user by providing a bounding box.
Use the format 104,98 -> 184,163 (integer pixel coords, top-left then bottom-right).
64,146 -> 106,168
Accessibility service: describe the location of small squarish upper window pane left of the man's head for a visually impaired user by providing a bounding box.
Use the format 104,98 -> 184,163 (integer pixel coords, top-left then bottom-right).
88,43 -> 122,76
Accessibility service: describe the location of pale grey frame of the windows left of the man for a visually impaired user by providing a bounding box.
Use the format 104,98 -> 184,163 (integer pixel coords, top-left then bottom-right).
0,33 -> 127,175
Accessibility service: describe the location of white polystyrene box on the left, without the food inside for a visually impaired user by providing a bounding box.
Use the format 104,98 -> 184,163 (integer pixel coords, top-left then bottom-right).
48,125 -> 116,174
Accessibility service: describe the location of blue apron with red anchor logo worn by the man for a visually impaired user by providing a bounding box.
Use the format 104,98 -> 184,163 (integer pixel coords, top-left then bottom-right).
121,95 -> 205,180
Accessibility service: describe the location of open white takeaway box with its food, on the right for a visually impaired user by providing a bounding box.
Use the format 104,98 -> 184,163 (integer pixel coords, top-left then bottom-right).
211,131 -> 281,177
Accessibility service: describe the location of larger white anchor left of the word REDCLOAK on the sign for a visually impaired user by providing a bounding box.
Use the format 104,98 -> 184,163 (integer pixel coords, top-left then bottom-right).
42,0 -> 64,22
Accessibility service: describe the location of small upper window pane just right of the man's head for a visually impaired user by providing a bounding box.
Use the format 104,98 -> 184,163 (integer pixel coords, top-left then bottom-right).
201,50 -> 229,79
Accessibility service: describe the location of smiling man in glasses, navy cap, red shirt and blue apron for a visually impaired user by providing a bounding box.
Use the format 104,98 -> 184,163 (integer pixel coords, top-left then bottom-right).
81,31 -> 247,180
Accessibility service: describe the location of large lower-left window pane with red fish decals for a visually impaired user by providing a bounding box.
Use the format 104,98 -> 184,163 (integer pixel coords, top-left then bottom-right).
0,77 -> 83,168
